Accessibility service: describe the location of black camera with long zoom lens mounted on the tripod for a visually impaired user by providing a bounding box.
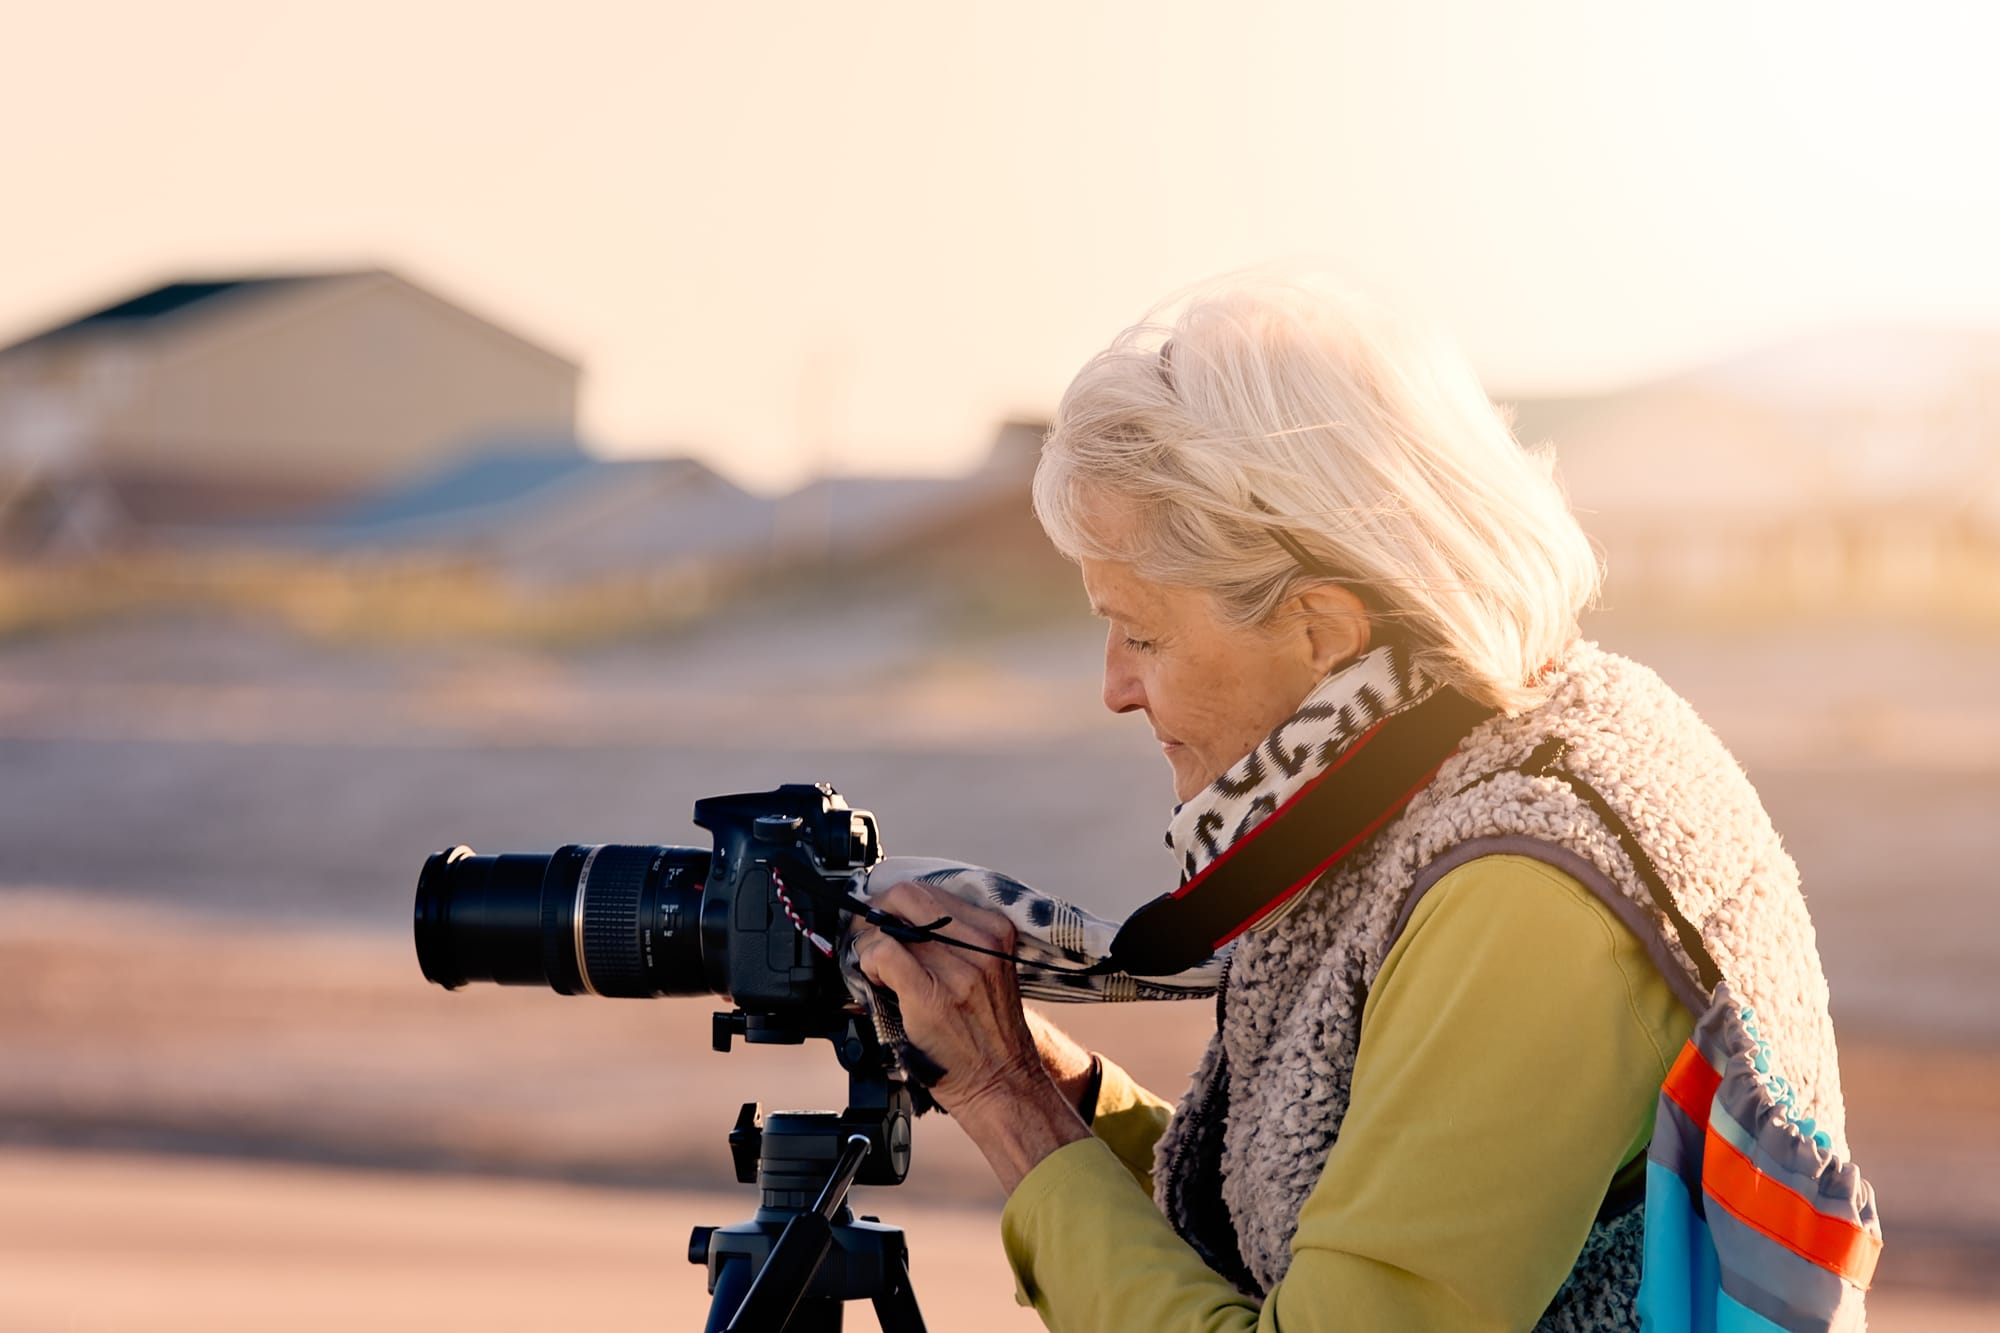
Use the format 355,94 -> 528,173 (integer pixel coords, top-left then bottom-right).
416,783 -> 882,1008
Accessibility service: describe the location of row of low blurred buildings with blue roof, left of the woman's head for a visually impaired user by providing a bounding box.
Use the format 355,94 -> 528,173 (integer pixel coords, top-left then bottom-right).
197,422 -> 1066,602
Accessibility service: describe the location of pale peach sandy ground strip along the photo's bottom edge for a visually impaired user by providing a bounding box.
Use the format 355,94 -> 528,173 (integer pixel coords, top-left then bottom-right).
0,1149 -> 2000,1333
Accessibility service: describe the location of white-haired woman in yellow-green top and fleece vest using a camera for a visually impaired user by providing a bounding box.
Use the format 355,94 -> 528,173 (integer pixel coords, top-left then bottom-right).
856,274 -> 1844,1333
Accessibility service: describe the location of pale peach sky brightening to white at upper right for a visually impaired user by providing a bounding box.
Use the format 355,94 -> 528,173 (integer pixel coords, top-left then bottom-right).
0,0 -> 2000,488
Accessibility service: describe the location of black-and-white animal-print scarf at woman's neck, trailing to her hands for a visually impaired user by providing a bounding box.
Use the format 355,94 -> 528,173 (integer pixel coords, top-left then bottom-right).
840,644 -> 1438,1020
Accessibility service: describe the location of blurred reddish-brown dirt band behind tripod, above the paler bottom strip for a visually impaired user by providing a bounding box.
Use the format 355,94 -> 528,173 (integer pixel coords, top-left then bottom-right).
0,893 -> 2000,1296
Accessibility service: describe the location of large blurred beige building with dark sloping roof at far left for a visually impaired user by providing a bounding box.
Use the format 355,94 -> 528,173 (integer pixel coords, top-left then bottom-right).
0,270 -> 578,542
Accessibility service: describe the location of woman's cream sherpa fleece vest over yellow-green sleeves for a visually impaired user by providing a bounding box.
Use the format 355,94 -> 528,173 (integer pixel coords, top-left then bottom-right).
1154,644 -> 1848,1329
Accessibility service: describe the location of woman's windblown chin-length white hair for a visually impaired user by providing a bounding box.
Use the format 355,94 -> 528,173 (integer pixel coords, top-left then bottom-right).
1034,278 -> 1600,711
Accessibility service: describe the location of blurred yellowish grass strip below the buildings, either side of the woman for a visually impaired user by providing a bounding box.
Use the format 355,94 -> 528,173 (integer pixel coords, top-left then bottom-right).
0,548 -> 2000,646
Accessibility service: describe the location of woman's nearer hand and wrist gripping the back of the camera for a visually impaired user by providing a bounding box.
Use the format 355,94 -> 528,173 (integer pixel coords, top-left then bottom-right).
854,883 -> 1090,1191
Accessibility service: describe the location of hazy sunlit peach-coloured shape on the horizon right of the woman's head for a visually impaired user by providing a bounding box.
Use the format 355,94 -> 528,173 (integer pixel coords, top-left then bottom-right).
1514,328 -> 2000,622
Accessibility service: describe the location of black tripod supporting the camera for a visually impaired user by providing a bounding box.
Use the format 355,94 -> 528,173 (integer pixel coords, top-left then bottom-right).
688,1011 -> 924,1333
